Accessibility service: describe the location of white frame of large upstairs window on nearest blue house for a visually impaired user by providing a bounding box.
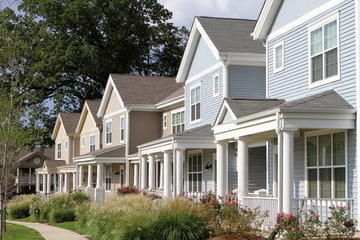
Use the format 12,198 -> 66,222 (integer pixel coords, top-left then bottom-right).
308,12 -> 340,88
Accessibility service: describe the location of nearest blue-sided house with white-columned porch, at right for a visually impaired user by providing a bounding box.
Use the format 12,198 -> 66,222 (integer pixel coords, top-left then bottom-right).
214,0 -> 360,227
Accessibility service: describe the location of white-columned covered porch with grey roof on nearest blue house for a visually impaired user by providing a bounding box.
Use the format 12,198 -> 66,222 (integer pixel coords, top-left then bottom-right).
213,91 -> 356,227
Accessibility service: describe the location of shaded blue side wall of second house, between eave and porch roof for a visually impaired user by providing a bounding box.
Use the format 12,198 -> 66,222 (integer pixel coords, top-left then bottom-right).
228,66 -> 266,98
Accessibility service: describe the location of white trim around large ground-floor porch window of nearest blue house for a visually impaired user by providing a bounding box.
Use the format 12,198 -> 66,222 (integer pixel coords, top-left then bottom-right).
304,130 -> 349,200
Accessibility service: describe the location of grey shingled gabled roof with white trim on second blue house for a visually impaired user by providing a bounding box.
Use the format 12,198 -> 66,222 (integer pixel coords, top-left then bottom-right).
176,17 -> 265,82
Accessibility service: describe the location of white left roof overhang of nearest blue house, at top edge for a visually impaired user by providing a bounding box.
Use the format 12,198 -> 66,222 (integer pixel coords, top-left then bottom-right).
251,0 -> 283,40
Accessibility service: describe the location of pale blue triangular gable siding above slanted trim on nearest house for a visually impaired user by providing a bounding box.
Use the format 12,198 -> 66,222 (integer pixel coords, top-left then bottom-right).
272,0 -> 329,31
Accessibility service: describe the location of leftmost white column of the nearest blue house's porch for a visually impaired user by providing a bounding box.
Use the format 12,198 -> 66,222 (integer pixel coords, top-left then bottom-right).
216,141 -> 228,198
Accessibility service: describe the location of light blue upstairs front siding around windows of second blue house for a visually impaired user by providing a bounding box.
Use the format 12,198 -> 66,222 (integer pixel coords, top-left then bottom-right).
185,67 -> 223,130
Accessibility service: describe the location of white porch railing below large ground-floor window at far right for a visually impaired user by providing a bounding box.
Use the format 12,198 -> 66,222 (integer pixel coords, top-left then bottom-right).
294,198 -> 354,222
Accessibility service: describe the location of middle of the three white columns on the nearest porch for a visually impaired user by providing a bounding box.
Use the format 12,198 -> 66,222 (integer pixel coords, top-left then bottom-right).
237,138 -> 249,204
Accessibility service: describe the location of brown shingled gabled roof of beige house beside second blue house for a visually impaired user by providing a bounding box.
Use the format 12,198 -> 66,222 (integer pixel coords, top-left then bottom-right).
98,74 -> 182,116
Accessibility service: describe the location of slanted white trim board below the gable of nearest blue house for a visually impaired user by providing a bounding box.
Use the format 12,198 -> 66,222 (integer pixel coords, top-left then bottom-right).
267,0 -> 344,41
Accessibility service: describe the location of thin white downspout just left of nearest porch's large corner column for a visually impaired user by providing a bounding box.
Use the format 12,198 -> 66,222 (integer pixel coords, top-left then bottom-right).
276,112 -> 283,212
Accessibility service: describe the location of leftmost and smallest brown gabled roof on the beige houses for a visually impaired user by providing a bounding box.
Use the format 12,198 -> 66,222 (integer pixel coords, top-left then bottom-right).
51,112 -> 80,140
